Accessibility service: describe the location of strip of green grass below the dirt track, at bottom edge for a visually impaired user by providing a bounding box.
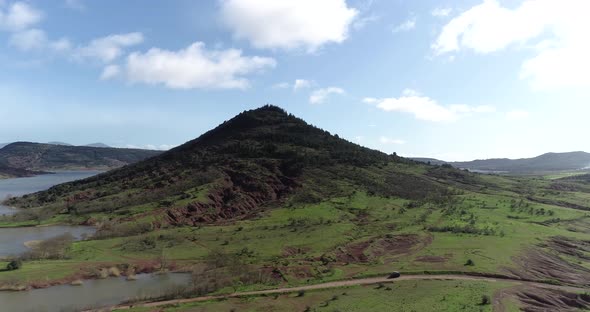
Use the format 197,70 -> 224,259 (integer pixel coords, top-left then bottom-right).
120,280 -> 509,312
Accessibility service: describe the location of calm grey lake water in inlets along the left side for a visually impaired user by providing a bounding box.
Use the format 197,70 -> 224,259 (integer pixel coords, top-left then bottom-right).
0,171 -> 190,312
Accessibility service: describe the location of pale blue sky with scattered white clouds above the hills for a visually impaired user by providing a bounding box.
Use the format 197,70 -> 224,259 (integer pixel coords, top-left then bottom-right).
0,0 -> 590,160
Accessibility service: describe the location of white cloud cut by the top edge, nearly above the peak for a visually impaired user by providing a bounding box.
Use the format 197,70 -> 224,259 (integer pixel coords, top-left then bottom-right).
221,0 -> 358,52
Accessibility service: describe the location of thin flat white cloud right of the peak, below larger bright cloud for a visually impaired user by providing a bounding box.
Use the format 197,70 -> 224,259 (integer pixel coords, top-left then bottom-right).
363,89 -> 495,122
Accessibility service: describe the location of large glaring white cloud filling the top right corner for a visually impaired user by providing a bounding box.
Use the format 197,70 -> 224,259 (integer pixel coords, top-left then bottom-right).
432,0 -> 590,90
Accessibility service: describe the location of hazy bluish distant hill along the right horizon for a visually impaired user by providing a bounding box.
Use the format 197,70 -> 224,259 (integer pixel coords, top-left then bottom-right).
413,152 -> 590,174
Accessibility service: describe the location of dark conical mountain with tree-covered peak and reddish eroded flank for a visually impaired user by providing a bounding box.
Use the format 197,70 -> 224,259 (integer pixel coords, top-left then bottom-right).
11,105 -> 443,224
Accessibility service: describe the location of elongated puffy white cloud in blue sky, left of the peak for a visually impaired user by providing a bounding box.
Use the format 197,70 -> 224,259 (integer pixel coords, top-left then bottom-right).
125,42 -> 276,89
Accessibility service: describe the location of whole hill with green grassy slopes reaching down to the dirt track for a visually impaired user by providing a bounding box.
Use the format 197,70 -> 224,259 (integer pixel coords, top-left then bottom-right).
0,106 -> 590,311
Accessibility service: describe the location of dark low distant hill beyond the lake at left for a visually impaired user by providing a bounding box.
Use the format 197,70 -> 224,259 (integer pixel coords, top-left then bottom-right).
0,142 -> 161,171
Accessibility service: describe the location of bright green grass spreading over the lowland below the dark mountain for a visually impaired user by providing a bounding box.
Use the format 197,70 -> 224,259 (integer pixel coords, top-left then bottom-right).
0,165 -> 590,311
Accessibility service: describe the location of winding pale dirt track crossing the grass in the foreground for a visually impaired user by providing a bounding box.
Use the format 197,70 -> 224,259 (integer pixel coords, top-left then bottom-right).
107,275 -> 588,311
